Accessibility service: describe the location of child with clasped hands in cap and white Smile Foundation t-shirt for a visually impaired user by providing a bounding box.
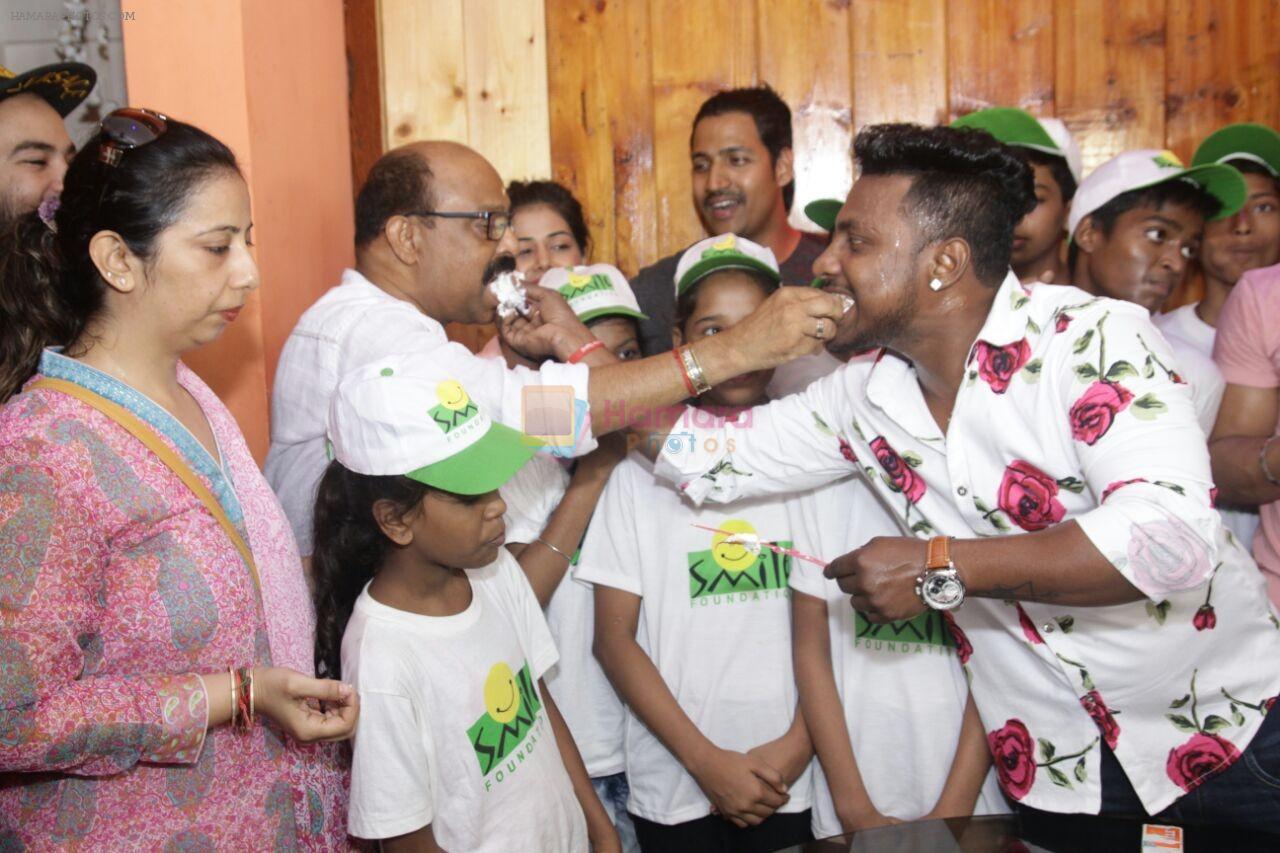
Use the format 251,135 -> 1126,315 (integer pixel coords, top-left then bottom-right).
586,234 -> 813,853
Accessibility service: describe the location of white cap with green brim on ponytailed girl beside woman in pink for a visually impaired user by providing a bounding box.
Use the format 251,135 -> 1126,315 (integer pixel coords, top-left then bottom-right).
329,352 -> 538,494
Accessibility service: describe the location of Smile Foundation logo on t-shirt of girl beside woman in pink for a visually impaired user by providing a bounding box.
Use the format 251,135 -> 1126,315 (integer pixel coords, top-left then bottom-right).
467,661 -> 543,790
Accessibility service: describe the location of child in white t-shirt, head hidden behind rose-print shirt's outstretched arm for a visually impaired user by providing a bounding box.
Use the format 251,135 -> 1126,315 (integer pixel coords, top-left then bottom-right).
787,435 -> 1009,838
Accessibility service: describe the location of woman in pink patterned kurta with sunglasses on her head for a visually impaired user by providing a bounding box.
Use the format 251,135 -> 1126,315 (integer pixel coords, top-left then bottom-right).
0,111 -> 355,850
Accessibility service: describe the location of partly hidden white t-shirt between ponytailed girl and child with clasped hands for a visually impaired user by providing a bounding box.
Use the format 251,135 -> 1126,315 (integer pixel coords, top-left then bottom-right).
499,453 -> 625,779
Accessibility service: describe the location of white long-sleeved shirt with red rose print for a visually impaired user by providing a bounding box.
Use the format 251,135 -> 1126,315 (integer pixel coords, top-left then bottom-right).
655,274 -> 1280,813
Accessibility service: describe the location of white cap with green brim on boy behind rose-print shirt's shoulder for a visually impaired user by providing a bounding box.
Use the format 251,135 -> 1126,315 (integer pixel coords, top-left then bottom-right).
1066,149 -> 1248,237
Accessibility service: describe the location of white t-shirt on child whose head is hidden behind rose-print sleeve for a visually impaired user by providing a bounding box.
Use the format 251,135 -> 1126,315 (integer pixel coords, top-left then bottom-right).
787,479 -> 1009,838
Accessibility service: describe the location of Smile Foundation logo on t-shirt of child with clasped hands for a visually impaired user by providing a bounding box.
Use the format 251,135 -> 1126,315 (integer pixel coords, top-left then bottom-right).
687,519 -> 791,603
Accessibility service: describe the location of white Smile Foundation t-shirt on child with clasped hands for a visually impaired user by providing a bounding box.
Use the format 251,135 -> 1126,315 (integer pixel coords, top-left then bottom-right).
575,453 -> 810,825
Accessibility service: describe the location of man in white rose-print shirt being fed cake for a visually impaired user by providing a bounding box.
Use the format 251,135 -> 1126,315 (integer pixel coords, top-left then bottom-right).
645,124 -> 1280,831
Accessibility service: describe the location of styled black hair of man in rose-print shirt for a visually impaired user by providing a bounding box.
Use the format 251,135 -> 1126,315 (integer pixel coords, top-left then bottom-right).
854,124 -> 1036,287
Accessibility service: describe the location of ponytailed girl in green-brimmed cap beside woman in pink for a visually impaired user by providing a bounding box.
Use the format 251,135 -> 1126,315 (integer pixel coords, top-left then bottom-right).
312,353 -> 618,853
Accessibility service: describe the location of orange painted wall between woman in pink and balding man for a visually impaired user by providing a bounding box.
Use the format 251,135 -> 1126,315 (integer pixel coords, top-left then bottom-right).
122,0 -> 355,462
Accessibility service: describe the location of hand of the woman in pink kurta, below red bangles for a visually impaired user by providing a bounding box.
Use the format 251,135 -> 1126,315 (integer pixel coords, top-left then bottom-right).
253,666 -> 360,743
